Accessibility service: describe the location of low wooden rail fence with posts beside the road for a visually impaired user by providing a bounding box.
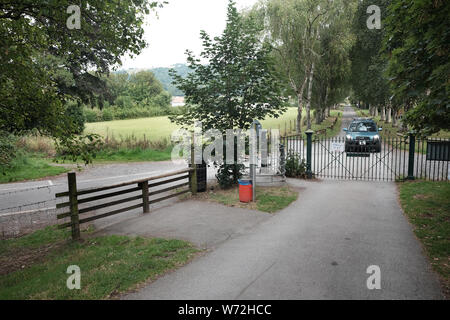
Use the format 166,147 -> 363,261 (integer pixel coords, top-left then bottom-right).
55,166 -> 197,240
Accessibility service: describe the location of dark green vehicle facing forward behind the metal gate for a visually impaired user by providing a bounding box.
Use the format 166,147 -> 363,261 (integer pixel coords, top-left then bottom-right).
344,119 -> 382,153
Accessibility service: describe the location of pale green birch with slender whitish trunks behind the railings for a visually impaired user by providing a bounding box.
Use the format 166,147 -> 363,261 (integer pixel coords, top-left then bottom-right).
250,0 -> 354,132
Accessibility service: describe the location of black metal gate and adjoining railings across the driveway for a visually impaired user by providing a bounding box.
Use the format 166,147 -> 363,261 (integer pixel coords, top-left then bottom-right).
282,132 -> 450,181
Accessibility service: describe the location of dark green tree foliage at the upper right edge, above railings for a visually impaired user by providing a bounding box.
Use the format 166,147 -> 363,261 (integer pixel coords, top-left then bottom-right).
384,0 -> 450,134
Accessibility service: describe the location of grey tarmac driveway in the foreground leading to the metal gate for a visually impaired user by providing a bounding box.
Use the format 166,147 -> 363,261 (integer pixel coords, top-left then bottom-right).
124,181 -> 442,299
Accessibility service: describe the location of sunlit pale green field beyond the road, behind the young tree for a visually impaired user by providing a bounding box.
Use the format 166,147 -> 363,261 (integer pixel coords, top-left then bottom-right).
86,108 -> 306,141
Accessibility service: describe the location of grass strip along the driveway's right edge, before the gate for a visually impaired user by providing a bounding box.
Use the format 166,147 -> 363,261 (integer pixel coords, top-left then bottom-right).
398,181 -> 450,299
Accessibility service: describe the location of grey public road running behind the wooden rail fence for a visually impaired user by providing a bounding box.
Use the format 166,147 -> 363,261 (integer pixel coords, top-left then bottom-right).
0,161 -> 204,238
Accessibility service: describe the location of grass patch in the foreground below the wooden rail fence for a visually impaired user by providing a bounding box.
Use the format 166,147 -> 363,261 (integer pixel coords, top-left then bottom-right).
0,227 -> 197,300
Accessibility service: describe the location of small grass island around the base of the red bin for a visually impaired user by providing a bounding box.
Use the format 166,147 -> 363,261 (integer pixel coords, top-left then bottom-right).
197,186 -> 298,213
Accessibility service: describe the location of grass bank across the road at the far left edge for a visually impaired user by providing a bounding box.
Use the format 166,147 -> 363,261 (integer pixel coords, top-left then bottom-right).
0,155 -> 69,183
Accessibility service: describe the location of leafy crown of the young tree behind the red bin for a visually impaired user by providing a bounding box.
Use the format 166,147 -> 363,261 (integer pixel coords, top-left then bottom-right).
171,1 -> 286,132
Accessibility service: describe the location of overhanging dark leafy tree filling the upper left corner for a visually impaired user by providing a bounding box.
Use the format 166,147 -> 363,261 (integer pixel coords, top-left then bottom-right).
0,0 -> 163,137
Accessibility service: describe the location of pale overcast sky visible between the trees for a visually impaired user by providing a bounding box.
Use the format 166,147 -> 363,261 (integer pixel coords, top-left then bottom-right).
121,0 -> 257,69
